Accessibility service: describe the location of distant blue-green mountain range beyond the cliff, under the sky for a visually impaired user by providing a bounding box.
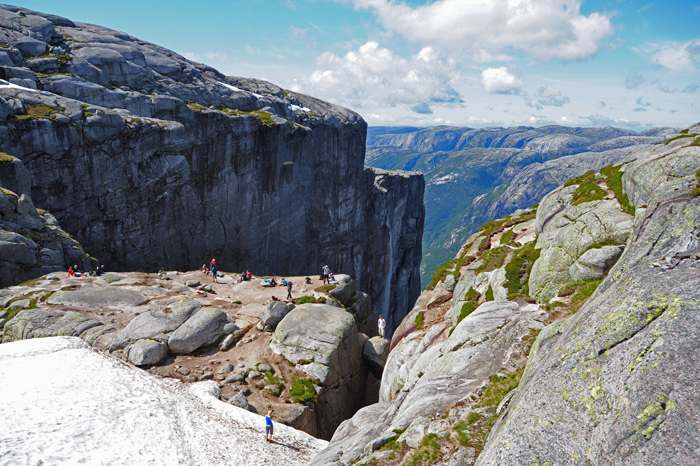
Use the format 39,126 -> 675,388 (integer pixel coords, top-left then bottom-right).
365,126 -> 676,286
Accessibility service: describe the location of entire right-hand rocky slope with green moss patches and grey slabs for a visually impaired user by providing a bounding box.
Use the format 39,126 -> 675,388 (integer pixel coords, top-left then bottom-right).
310,125 -> 700,466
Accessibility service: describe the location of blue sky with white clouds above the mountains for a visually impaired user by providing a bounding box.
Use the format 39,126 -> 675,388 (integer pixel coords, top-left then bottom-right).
10,0 -> 700,131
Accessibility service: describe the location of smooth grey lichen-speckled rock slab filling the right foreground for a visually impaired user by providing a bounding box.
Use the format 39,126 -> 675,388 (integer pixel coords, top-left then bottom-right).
478,126 -> 700,465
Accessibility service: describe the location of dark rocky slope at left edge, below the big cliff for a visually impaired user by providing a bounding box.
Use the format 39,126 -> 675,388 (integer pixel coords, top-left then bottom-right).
0,183 -> 98,288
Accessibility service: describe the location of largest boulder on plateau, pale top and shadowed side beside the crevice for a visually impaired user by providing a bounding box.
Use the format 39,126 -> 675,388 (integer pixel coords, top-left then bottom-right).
270,304 -> 367,438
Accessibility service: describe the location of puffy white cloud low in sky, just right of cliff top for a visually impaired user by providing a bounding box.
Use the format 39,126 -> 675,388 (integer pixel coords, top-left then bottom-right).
292,42 -> 462,109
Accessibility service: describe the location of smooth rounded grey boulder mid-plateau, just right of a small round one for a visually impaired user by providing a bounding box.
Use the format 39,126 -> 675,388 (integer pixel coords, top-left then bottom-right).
168,307 -> 228,354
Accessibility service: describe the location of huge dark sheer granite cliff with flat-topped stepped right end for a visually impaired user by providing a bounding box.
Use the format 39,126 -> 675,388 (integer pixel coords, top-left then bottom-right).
0,6 -> 424,325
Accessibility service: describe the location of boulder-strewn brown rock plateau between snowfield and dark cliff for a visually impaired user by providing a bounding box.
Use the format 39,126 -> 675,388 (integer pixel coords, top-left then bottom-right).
0,271 -> 388,439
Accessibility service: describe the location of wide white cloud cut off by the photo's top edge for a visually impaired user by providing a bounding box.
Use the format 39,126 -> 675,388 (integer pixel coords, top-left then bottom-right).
355,0 -> 614,60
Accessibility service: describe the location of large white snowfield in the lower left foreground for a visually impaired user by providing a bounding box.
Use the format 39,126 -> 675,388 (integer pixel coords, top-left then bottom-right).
0,337 -> 328,466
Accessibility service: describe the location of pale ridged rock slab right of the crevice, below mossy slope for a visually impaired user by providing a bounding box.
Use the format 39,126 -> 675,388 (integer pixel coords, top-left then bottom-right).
311,300 -> 542,466
